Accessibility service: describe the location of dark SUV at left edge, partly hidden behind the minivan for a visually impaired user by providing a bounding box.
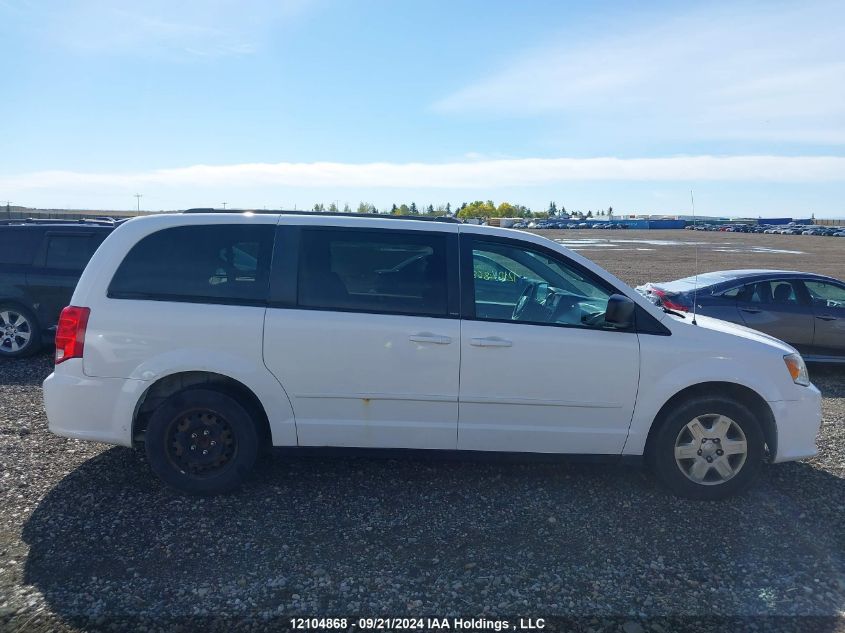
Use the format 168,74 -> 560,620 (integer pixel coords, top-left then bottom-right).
0,219 -> 117,358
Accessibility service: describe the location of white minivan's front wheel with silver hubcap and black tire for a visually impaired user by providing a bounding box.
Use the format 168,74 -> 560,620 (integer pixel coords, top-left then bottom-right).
650,398 -> 765,499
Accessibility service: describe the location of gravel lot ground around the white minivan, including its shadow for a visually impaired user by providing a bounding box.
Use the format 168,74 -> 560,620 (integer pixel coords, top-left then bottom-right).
0,231 -> 845,633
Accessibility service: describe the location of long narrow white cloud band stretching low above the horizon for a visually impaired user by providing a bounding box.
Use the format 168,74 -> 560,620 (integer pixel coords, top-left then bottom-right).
6,156 -> 845,196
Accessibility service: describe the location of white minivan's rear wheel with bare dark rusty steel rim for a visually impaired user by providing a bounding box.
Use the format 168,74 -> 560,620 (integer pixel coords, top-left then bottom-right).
145,389 -> 259,495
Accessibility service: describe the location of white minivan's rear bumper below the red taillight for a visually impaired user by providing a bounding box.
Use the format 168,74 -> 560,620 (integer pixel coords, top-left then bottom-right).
44,359 -> 149,446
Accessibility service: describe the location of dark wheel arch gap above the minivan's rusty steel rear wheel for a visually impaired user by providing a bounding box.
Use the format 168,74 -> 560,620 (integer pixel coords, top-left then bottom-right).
132,371 -> 273,449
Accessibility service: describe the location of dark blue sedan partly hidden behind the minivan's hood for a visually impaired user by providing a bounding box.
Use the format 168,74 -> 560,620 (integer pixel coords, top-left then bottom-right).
637,270 -> 845,363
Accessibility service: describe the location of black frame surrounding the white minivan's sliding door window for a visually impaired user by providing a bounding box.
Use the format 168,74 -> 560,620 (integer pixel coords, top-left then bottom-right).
267,224 -> 460,320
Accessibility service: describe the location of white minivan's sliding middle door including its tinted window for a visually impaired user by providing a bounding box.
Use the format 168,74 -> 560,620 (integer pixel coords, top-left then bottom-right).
264,224 -> 460,449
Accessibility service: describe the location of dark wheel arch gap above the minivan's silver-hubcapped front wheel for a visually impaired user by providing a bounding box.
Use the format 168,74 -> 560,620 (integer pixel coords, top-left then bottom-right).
644,381 -> 777,461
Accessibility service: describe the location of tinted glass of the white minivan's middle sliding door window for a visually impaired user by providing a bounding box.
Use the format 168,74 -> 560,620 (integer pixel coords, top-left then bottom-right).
298,229 -> 447,316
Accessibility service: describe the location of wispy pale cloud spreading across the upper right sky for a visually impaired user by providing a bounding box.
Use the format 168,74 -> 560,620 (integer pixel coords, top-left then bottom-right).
434,2 -> 845,144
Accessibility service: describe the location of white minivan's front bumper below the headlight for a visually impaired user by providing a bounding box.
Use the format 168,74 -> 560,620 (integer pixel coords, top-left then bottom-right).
769,385 -> 822,463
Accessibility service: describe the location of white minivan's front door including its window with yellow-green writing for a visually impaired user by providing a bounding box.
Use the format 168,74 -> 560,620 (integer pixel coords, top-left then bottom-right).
458,235 -> 639,454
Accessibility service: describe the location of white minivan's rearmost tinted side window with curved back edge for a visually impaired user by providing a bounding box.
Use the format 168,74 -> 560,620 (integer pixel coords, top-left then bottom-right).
109,224 -> 273,305
